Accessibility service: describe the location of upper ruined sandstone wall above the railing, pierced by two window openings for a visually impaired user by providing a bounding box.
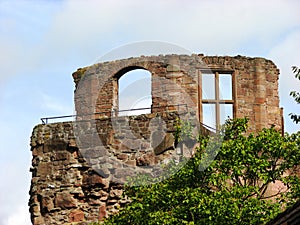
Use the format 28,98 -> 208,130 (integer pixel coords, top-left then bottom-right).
73,54 -> 283,132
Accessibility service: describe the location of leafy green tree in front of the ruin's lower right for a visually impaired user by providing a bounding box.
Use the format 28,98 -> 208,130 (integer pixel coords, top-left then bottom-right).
104,119 -> 300,225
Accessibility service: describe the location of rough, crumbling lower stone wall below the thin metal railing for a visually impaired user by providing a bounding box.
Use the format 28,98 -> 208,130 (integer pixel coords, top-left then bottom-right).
29,112 -> 195,225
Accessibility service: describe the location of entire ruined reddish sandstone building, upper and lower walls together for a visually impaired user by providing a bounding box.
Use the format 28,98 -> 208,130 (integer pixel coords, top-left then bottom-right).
29,54 -> 283,225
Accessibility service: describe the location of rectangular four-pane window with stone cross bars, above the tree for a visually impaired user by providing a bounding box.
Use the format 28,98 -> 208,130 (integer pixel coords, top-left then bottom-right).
199,71 -> 234,129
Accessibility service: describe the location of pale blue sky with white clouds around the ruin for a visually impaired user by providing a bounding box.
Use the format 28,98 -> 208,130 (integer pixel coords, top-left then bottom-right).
0,0 -> 300,225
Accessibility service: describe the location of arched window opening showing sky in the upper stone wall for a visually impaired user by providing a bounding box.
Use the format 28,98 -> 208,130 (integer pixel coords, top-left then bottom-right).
118,69 -> 152,116
